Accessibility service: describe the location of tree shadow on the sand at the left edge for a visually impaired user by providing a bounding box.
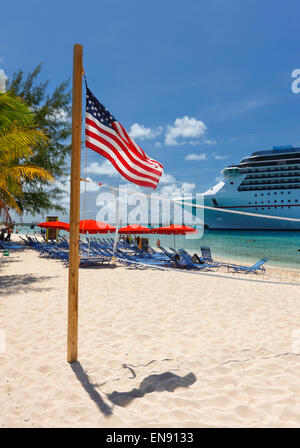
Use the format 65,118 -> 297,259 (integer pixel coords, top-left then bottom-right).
0,274 -> 53,296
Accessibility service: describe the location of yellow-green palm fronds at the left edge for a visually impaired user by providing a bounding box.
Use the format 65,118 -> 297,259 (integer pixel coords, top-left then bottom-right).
0,92 -> 52,214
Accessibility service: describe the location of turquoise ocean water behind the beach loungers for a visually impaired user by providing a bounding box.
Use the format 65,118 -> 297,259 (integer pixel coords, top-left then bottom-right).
18,227 -> 300,269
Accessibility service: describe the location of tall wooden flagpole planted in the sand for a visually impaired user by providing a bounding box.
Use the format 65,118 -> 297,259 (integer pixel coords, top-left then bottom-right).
67,44 -> 83,362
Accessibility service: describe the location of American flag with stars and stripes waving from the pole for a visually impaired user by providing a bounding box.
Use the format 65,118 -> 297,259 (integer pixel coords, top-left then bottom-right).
85,86 -> 163,189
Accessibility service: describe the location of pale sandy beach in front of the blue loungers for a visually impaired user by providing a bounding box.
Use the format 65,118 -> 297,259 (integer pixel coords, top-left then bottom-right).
0,234 -> 300,428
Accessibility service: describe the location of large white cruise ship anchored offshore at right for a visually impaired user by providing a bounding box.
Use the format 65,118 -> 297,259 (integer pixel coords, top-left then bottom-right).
203,146 -> 300,230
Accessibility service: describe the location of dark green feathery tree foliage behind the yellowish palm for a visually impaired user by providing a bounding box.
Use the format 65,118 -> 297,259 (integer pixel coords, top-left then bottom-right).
7,64 -> 71,213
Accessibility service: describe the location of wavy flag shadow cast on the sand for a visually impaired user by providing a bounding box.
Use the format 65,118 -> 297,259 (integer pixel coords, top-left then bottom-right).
107,372 -> 197,406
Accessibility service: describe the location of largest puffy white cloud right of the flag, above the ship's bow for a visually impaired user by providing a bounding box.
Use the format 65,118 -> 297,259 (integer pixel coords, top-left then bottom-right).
165,115 -> 206,146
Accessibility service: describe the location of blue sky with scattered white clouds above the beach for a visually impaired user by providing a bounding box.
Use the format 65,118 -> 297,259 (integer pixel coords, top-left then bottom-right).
0,0 -> 300,220
